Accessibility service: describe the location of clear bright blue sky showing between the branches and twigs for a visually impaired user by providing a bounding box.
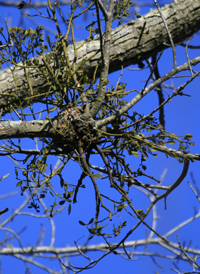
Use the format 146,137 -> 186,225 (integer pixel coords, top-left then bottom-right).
0,1 -> 200,274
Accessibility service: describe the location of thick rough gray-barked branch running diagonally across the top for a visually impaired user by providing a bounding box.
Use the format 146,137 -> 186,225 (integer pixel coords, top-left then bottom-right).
0,0 -> 200,108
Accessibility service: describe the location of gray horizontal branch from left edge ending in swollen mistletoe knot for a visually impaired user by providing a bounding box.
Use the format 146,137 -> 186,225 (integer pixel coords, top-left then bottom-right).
0,107 -> 95,154
